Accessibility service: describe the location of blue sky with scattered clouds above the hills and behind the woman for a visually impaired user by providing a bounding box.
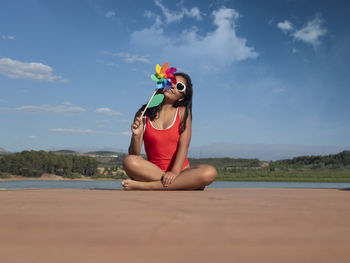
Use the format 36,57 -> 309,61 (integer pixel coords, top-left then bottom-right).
0,0 -> 350,154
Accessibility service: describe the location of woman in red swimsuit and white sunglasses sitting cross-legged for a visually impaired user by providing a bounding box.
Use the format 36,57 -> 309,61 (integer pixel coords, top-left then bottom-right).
122,73 -> 217,190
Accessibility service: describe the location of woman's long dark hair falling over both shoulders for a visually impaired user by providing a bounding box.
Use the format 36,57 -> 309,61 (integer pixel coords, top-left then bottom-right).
139,72 -> 193,133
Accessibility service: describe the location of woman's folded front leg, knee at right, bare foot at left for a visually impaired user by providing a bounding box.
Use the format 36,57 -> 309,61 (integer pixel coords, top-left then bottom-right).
122,164 -> 217,190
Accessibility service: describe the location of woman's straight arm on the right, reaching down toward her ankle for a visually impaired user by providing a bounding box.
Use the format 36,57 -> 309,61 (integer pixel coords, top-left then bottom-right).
171,110 -> 192,175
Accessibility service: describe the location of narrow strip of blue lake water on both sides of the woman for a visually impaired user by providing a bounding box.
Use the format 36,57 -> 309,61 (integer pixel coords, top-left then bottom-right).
0,180 -> 350,190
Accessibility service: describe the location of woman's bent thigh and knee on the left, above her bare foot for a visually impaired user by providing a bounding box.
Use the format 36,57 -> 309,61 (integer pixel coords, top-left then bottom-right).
123,155 -> 164,182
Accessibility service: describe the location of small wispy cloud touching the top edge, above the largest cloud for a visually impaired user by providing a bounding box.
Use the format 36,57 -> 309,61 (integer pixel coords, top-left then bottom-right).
154,0 -> 202,24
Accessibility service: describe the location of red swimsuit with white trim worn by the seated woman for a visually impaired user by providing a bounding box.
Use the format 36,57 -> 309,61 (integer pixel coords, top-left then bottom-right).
143,108 -> 189,172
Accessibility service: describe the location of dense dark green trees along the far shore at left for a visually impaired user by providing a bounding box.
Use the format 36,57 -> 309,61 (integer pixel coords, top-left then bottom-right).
0,151 -> 98,177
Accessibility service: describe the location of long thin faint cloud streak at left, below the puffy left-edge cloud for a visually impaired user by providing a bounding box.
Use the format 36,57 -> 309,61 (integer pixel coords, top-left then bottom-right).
16,102 -> 85,114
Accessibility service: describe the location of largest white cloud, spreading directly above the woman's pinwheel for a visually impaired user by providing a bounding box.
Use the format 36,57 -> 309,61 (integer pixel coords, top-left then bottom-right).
131,8 -> 258,67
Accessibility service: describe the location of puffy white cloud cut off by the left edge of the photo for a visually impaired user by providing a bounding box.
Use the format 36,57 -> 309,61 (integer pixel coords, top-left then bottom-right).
0,58 -> 68,82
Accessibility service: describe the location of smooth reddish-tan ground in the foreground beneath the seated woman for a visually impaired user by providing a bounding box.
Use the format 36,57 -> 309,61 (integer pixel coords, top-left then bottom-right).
0,189 -> 350,263
